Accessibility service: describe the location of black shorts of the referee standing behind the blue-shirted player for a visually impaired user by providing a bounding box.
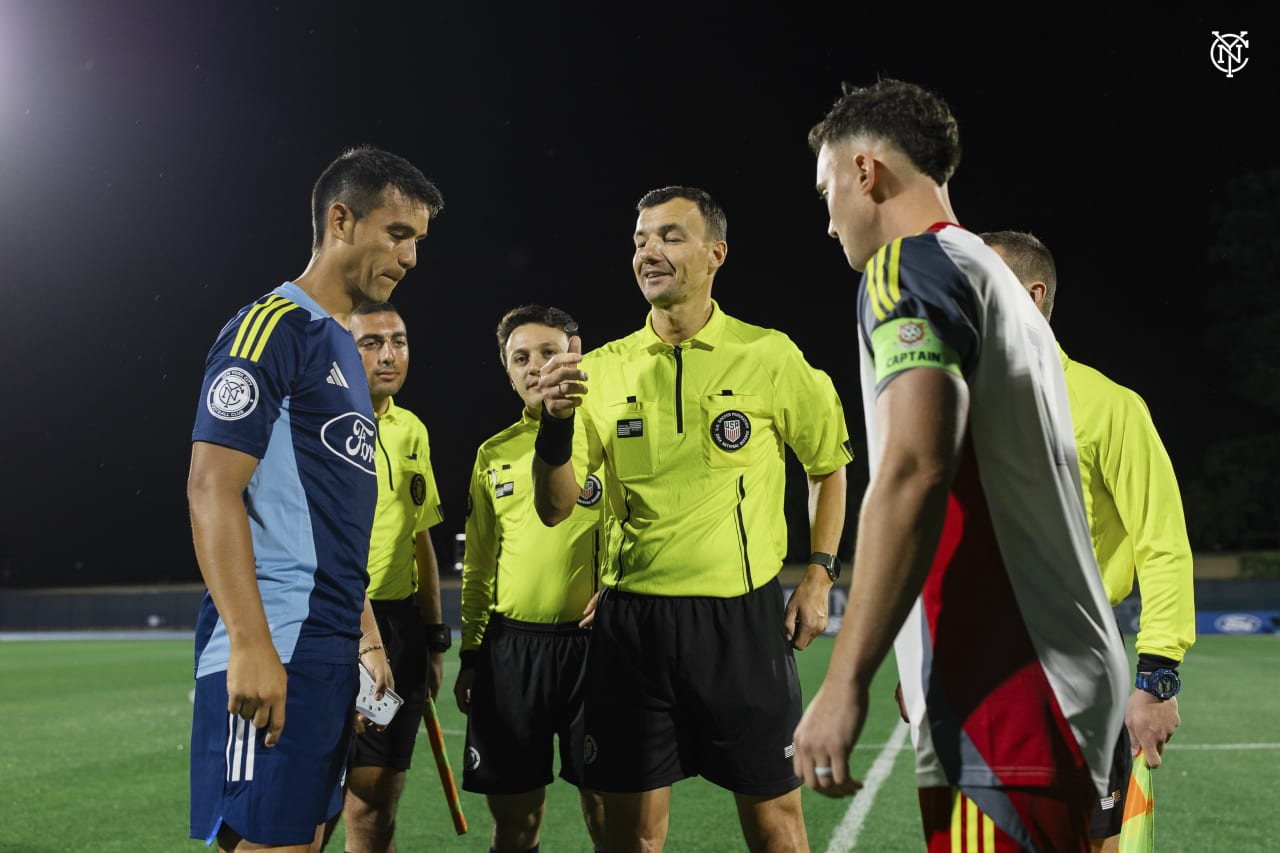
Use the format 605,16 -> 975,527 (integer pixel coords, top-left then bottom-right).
348,596 -> 429,770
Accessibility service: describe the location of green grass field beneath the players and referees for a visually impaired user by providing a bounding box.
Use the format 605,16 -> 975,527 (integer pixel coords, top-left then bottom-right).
0,637 -> 1280,853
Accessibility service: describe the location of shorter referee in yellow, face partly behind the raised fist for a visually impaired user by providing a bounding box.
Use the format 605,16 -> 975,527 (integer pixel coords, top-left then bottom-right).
453,305 -> 612,853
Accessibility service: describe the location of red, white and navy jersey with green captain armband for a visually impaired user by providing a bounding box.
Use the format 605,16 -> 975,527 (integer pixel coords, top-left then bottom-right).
858,224 -> 1128,793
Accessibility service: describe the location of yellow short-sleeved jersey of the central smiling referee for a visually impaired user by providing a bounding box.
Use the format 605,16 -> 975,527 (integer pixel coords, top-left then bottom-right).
573,301 -> 852,598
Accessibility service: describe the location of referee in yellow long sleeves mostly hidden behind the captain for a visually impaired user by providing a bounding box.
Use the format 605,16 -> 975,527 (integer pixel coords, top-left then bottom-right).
982,231 -> 1196,850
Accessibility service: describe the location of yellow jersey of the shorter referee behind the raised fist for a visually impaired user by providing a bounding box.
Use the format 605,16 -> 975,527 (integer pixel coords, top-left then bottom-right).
462,412 -> 611,652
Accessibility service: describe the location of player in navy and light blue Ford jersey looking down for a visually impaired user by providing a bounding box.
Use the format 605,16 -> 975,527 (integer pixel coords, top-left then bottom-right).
187,147 -> 444,852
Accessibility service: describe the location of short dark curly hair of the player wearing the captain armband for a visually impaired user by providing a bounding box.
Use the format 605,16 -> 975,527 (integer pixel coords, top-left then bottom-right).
809,78 -> 960,187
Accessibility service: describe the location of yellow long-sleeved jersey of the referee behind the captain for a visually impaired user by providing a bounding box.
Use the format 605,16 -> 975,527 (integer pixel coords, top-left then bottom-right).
1059,347 -> 1196,661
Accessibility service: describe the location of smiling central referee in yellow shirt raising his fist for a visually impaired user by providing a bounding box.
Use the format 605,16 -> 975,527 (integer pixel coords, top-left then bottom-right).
534,187 -> 852,850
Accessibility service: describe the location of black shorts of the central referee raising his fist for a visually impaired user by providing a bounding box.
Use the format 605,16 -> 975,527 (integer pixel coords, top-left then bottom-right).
585,578 -> 803,797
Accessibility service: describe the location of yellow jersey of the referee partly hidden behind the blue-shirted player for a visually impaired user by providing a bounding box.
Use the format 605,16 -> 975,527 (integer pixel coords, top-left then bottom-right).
369,400 -> 444,601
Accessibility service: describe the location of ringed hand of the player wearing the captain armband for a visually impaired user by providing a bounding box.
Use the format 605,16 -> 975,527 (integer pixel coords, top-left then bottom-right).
791,681 -> 867,798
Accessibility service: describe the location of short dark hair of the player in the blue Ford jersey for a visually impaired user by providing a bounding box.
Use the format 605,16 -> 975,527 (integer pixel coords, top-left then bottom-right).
311,145 -> 444,248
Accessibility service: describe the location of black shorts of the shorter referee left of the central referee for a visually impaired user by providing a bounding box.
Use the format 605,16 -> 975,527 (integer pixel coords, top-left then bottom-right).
462,613 -> 590,794
